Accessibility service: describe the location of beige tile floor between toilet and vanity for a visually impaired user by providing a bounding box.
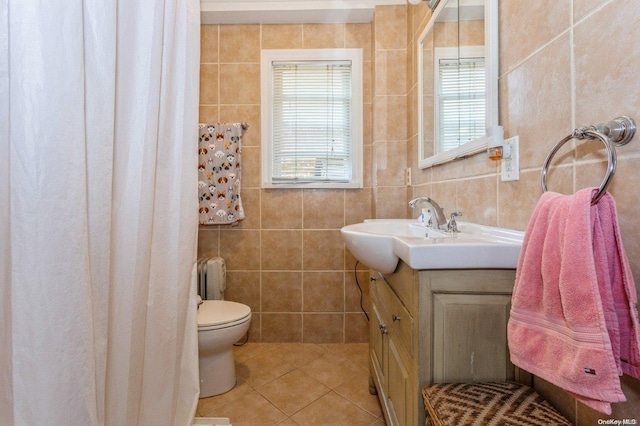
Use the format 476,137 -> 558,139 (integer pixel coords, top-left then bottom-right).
196,343 -> 385,426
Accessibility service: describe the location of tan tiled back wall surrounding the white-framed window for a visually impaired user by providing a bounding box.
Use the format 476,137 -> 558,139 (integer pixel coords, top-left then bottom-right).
198,24 -> 376,343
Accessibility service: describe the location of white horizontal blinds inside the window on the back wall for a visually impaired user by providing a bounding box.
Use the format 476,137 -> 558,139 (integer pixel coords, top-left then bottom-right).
271,61 -> 353,183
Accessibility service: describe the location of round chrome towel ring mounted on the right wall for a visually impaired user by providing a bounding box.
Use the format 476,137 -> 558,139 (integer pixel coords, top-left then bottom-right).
542,116 -> 636,205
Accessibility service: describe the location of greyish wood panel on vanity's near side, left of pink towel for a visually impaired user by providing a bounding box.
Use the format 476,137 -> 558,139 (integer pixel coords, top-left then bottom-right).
433,293 -> 513,383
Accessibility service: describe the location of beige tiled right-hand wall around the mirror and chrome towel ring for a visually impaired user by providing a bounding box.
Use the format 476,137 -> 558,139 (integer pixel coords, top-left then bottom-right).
407,0 -> 640,425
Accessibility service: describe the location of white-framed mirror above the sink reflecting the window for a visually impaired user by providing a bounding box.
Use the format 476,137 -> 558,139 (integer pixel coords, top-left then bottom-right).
418,0 -> 498,169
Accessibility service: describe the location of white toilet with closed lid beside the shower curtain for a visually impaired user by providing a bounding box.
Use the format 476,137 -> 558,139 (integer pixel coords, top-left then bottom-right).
198,300 -> 251,398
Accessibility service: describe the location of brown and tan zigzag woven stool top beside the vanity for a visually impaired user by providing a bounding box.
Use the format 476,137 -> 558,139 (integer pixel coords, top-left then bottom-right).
422,382 -> 571,426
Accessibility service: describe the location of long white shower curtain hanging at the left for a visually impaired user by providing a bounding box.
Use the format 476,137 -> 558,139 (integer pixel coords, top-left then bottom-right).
0,0 -> 200,426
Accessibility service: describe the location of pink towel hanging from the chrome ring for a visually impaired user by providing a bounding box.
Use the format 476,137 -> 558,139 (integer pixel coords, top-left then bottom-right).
508,188 -> 640,414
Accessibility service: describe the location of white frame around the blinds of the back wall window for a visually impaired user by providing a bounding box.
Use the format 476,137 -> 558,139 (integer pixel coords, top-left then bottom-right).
260,48 -> 363,189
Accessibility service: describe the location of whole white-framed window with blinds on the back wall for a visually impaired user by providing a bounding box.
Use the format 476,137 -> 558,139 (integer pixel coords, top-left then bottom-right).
261,49 -> 362,188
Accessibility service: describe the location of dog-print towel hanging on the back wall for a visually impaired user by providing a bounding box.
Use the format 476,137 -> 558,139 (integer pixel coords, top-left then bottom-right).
198,123 -> 246,225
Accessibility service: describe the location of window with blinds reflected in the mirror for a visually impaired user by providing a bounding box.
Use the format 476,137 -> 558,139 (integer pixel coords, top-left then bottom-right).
434,47 -> 486,152
